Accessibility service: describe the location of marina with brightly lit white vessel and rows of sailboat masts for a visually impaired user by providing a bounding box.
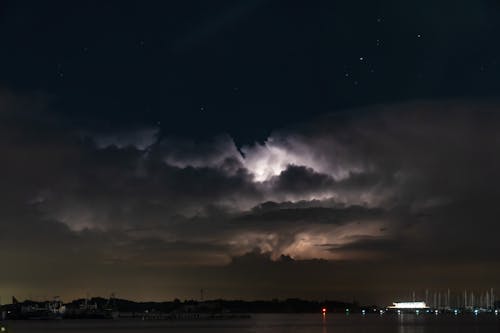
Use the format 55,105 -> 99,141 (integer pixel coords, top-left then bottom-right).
379,288 -> 500,316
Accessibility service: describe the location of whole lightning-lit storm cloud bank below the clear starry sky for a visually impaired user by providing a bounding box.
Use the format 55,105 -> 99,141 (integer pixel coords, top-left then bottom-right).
0,92 -> 500,304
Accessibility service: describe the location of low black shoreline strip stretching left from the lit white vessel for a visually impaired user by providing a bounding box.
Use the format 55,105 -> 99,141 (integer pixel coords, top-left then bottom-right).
0,297 -> 377,319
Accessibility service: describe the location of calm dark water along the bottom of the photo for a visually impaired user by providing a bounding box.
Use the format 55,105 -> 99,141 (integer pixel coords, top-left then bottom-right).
3,314 -> 500,333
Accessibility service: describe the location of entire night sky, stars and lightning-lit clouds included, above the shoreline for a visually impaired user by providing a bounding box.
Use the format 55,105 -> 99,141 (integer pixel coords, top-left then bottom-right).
0,0 -> 500,303
